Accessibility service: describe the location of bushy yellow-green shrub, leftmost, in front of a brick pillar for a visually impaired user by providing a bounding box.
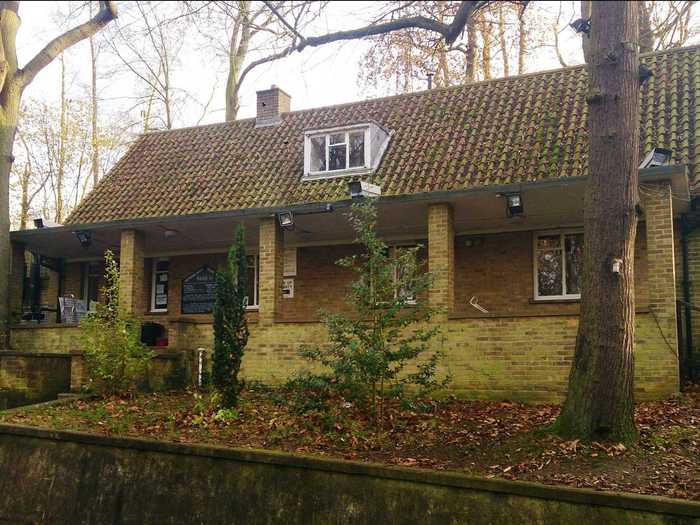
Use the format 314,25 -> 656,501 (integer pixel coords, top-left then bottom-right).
80,250 -> 153,394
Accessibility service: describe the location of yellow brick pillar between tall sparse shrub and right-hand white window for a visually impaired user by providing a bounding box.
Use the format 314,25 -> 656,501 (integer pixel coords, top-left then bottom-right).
428,203 -> 455,322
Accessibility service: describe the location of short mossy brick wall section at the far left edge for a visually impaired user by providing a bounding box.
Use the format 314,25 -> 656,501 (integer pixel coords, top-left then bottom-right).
0,351 -> 73,409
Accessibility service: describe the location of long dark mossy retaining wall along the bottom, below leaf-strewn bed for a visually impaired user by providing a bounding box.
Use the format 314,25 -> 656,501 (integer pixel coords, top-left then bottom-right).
0,425 -> 700,525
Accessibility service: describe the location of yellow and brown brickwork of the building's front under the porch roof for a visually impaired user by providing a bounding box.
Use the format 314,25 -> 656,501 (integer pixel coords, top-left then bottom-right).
13,194 -> 680,401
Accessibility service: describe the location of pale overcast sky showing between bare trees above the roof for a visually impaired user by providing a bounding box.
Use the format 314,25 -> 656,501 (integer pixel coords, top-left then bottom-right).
13,1 -> 700,126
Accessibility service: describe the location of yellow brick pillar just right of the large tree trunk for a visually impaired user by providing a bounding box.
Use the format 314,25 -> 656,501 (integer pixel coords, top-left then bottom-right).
643,182 -> 678,380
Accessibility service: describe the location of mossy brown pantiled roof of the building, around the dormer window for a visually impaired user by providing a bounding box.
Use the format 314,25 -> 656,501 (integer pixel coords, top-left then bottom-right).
68,47 -> 700,224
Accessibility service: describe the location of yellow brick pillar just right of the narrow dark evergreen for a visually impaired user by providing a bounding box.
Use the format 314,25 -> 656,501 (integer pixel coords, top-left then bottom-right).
258,217 -> 284,324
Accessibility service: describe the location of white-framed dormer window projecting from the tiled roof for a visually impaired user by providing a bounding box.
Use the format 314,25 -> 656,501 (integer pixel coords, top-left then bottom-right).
304,122 -> 389,179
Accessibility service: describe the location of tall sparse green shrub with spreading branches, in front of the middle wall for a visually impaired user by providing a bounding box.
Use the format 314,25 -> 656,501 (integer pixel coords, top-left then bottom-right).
292,201 -> 449,425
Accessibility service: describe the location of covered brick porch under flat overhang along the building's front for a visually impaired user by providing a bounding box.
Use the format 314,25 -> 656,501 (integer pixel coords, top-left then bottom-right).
6,167 -> 688,401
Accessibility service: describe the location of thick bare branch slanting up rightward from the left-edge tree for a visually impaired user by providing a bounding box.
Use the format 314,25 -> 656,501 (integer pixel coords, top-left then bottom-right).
18,1 -> 117,87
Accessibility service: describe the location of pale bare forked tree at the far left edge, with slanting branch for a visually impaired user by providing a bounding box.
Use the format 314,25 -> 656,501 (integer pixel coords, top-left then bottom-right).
0,1 -> 117,345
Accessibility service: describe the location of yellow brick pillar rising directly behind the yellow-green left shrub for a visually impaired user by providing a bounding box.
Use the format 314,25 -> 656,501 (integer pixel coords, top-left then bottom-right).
119,230 -> 146,315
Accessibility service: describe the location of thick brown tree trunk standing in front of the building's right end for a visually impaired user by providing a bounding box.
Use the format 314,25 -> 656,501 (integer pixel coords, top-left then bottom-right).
558,1 -> 639,441
